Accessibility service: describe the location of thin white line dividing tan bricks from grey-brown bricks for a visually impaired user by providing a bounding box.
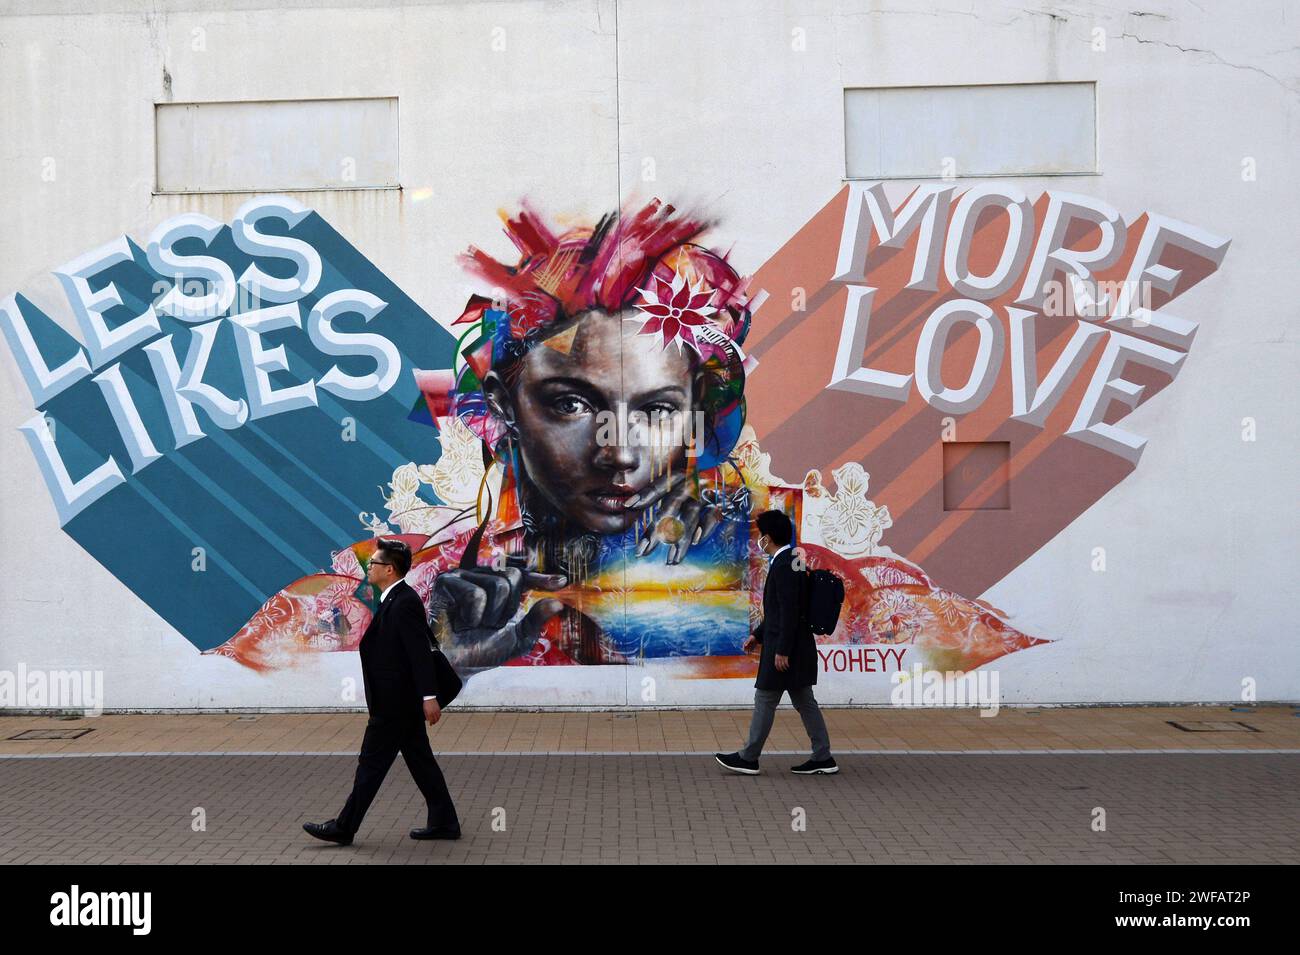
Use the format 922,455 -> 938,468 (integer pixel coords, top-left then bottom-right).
0,748 -> 1300,760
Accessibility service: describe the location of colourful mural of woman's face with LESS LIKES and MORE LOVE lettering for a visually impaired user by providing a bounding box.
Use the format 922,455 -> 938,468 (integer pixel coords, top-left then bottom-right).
0,183 -> 1229,694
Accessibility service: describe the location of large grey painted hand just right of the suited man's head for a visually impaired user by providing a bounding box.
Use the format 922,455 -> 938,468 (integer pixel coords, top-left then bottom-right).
433,567 -> 568,669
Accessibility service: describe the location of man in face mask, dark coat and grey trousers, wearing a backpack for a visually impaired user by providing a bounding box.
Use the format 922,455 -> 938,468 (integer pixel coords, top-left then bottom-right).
715,511 -> 840,776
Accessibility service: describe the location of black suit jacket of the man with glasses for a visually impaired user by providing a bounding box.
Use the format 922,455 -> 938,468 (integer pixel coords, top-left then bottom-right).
360,581 -> 438,719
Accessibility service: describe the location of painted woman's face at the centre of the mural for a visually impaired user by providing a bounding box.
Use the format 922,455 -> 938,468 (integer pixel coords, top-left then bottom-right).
491,312 -> 693,534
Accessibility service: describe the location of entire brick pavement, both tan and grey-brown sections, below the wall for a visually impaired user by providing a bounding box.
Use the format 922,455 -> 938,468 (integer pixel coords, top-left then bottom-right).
0,706 -> 1300,865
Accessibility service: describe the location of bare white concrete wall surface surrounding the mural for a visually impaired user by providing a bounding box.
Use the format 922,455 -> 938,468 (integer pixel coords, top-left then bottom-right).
0,0 -> 1300,708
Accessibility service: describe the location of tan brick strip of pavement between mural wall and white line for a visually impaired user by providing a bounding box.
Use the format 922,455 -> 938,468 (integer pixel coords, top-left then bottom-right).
0,703 -> 1300,756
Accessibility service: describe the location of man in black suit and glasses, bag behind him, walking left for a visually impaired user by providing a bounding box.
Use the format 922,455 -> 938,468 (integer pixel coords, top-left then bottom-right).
303,539 -> 460,846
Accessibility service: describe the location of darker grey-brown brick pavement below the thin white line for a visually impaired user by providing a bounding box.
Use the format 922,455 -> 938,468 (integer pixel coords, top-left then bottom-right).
0,752 -> 1300,865
